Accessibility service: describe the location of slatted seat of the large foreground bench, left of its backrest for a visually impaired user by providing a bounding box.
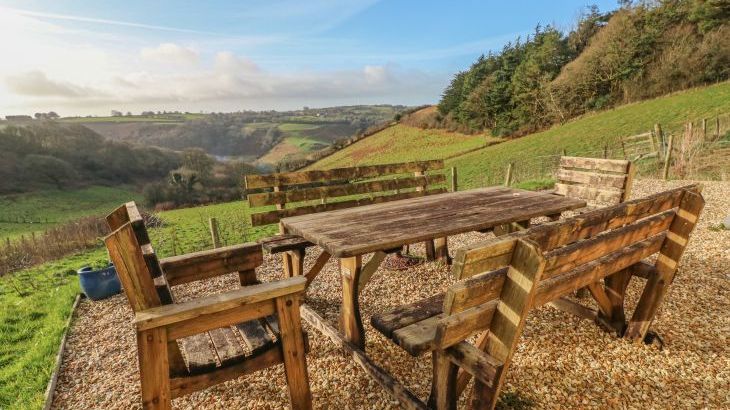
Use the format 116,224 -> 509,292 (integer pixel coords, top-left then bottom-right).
370,293 -> 445,356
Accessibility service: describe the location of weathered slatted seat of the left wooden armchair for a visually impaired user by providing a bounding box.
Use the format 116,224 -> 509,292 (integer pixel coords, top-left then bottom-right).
178,315 -> 309,375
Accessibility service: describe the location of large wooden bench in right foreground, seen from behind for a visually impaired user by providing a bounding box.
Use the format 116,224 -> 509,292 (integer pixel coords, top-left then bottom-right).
372,186 -> 704,409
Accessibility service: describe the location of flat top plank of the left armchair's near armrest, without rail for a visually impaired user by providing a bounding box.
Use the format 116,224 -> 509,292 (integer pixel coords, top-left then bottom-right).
134,277 -> 307,339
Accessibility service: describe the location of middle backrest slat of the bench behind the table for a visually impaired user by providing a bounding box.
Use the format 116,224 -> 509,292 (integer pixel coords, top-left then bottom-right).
248,174 -> 446,207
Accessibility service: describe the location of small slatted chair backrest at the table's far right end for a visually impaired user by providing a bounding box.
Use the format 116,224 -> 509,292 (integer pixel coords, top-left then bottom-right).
555,157 -> 635,205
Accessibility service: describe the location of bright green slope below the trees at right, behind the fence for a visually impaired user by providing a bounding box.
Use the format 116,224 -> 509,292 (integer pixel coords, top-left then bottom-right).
447,82 -> 730,188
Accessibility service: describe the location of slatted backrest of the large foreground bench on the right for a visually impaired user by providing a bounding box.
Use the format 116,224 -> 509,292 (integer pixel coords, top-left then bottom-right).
437,185 -> 704,350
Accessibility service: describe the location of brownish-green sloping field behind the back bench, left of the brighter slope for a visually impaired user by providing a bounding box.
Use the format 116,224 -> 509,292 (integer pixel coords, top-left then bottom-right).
309,124 -> 496,169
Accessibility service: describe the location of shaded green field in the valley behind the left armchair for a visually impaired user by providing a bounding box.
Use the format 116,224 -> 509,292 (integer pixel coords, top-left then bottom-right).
0,186 -> 142,241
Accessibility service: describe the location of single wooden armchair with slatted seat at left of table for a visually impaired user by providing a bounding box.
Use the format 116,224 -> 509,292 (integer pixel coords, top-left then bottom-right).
105,202 -> 311,409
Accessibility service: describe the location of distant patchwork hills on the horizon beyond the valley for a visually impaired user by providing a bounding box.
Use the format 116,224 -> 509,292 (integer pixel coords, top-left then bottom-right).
61,105 -> 406,168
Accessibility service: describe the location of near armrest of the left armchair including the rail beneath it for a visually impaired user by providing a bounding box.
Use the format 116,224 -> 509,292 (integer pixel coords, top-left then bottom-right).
134,276 -> 307,339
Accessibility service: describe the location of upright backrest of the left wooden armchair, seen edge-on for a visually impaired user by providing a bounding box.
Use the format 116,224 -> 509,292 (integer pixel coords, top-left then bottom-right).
104,202 -> 173,312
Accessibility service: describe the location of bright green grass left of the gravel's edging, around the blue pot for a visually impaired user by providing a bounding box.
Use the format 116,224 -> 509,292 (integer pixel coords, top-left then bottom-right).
0,248 -> 106,409
